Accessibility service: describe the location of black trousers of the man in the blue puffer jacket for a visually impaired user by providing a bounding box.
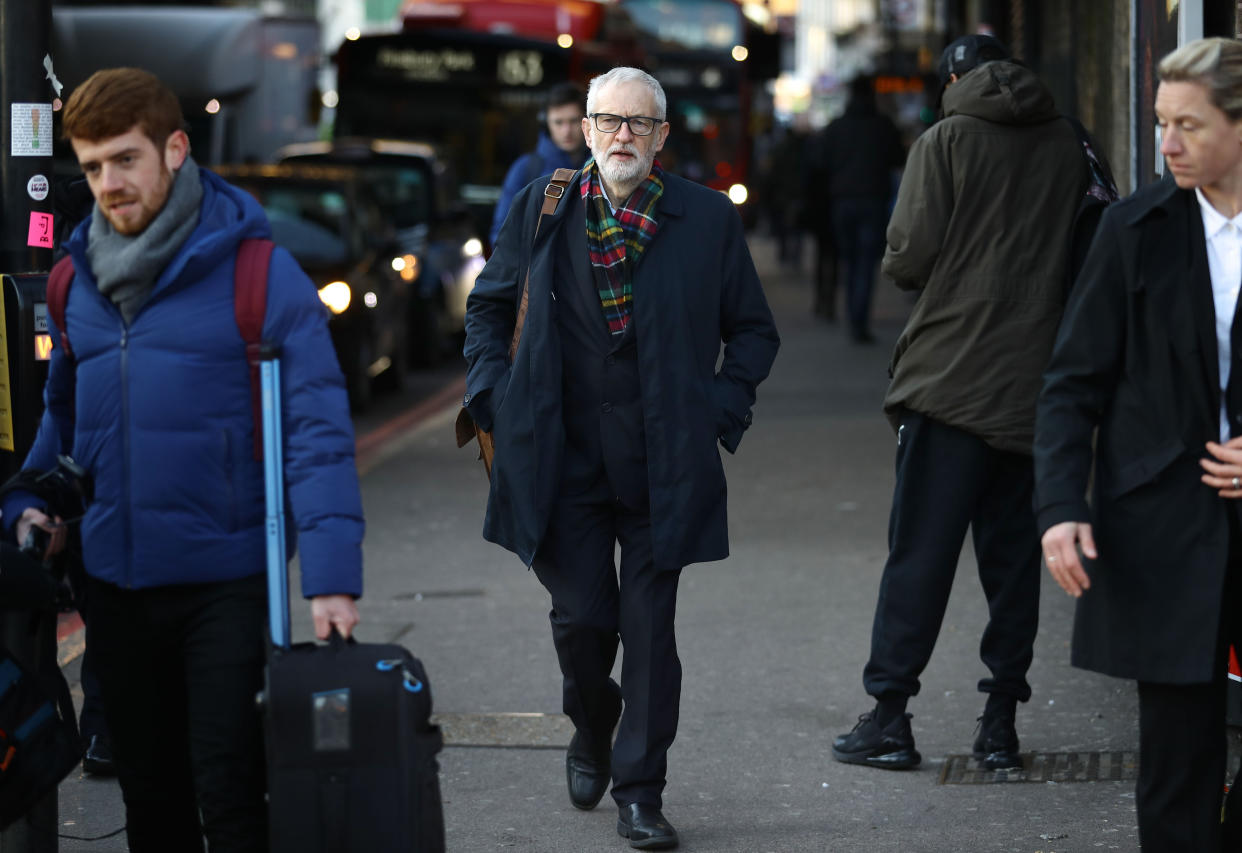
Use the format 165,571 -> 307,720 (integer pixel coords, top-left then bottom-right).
87,575 -> 267,853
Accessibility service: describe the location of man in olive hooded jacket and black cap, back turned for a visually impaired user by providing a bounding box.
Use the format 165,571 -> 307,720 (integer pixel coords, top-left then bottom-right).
832,35 -> 1088,770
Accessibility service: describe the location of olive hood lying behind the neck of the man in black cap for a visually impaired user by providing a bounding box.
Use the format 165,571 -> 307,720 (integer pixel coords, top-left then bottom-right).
941,61 -> 1058,124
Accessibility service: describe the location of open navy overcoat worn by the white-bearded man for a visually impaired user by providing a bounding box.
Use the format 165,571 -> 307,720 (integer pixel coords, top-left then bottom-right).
465,167 -> 780,569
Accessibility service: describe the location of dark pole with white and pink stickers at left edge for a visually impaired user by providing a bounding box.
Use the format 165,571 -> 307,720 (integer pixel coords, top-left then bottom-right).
0,0 -> 60,853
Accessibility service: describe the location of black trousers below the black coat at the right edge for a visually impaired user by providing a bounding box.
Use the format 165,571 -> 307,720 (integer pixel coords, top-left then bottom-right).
1137,515 -> 1242,853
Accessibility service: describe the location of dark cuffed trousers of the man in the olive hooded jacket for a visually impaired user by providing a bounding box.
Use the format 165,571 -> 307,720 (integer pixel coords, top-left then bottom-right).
863,412 -> 1040,702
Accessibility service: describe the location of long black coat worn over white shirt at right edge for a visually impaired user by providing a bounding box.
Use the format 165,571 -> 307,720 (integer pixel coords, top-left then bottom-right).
1035,181 -> 1242,683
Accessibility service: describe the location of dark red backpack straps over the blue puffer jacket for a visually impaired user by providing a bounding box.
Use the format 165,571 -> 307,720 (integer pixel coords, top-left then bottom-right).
47,240 -> 274,459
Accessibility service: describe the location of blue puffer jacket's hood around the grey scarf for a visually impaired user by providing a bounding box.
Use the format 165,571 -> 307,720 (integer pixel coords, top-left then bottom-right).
65,162 -> 272,276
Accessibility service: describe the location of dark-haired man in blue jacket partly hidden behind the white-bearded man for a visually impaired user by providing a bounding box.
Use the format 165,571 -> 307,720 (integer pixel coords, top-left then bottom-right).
488,83 -> 589,247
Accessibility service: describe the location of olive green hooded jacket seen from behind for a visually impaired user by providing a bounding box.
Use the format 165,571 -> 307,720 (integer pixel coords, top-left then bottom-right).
883,62 -> 1089,454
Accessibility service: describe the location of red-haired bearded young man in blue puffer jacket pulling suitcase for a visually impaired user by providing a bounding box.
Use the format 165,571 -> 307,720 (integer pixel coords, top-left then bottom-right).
2,68 -> 363,853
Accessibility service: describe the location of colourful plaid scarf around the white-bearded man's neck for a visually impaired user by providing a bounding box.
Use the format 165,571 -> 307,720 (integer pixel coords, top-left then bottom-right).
581,158 -> 664,335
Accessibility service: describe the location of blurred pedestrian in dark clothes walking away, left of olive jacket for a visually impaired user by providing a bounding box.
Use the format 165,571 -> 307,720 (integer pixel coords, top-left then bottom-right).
810,76 -> 905,344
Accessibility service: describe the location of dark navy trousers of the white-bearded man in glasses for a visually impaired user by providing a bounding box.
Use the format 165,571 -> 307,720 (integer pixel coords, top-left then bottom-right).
534,478 -> 682,806
